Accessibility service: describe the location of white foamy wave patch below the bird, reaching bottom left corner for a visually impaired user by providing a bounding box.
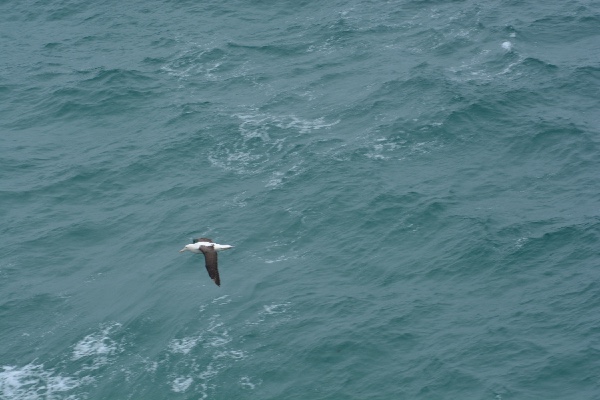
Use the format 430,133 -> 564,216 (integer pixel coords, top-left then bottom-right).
0,295 -> 290,400
